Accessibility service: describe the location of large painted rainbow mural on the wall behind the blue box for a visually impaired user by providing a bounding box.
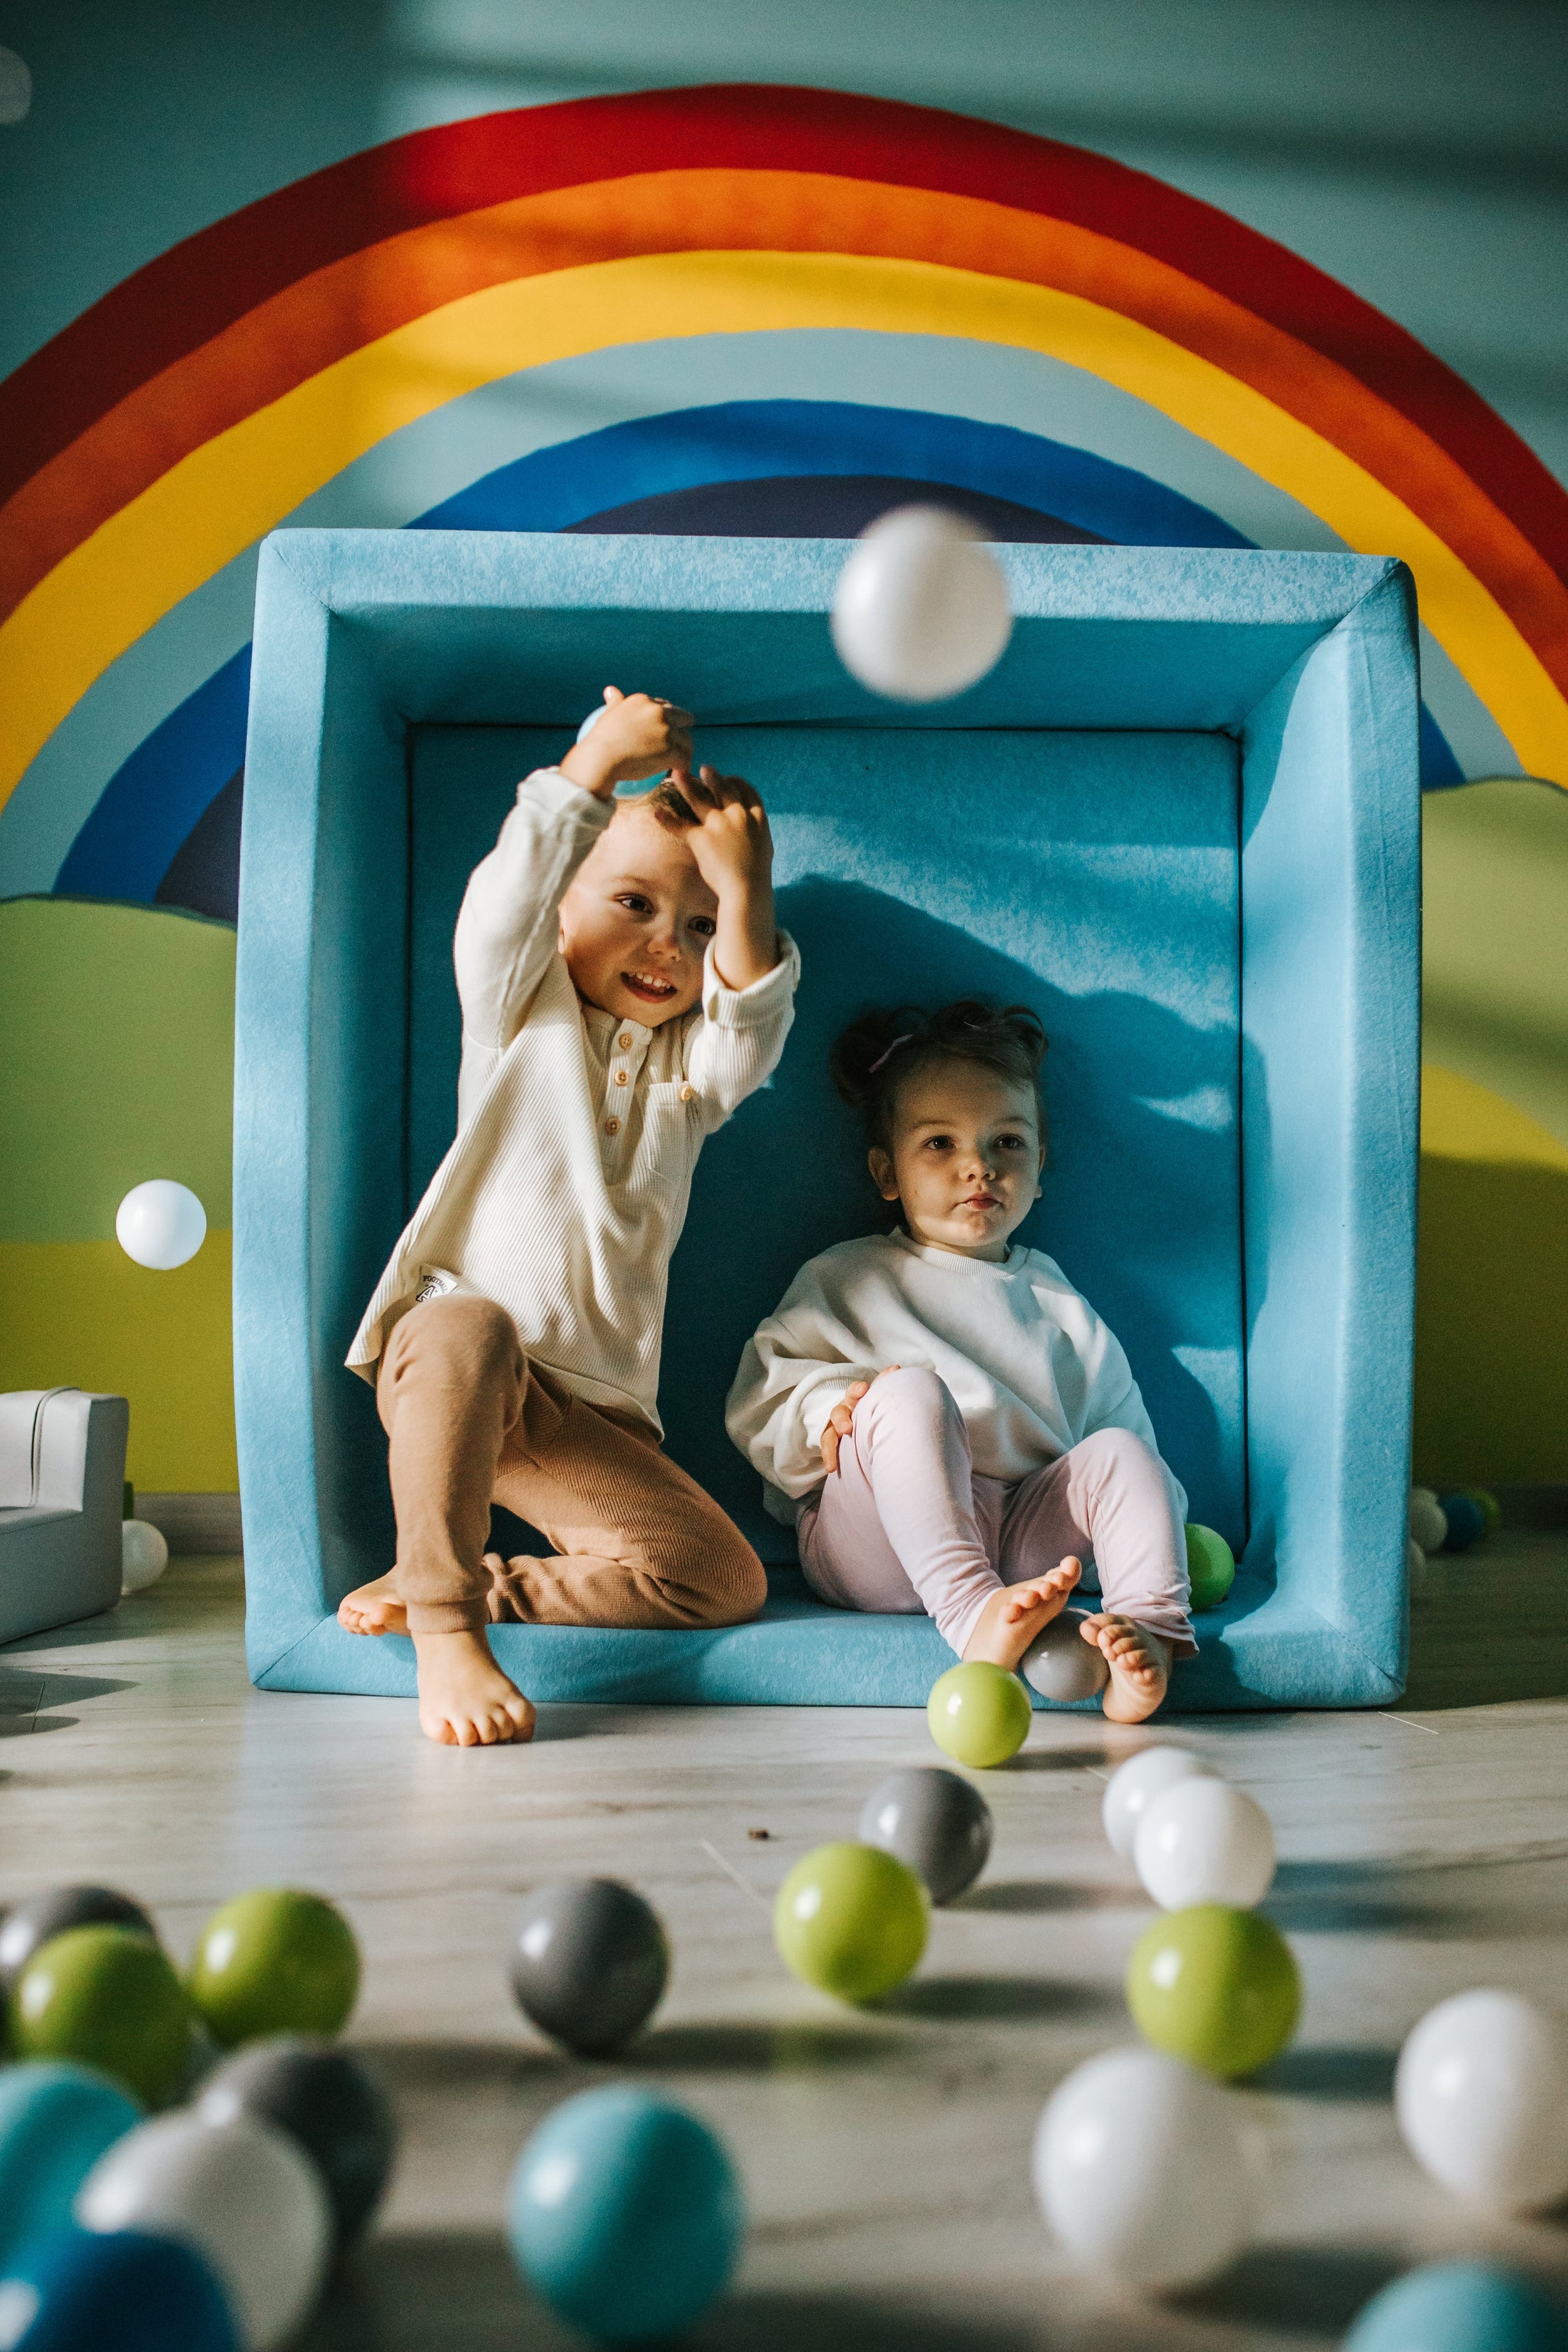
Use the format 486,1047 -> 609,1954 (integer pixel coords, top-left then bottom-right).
0,85 -> 1568,1484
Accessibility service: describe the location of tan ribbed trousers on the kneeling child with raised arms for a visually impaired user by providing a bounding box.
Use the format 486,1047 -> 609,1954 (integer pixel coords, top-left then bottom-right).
376,1296 -> 766,1632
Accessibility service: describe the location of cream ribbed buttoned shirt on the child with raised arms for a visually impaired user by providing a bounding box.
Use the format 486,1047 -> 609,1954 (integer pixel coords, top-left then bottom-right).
348,769 -> 799,1428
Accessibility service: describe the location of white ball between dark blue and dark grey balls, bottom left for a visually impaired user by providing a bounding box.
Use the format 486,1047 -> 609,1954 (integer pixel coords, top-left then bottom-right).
76,2112 -> 331,2352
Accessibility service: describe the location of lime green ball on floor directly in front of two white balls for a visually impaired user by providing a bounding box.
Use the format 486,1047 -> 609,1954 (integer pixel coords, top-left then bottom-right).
1126,1903 -> 1302,2075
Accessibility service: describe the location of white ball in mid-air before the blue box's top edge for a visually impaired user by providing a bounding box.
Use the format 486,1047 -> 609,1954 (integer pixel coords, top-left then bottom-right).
832,506 -> 1013,703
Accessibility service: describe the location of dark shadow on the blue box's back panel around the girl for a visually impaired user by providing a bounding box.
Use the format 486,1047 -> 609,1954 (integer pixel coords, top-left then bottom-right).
661,877 -> 1244,1559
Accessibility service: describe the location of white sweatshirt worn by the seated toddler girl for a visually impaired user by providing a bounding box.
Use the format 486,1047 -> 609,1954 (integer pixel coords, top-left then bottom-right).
724,1232 -> 1187,1524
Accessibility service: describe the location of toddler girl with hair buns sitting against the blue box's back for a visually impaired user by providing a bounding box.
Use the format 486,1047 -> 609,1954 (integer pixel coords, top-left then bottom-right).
726,1000 -> 1195,1724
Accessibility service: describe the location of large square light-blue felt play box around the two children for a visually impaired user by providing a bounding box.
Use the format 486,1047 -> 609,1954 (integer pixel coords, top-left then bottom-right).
235,532 -> 1418,1708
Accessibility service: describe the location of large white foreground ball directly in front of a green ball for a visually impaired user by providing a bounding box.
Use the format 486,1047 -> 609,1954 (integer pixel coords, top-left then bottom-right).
1032,2051 -> 1253,2294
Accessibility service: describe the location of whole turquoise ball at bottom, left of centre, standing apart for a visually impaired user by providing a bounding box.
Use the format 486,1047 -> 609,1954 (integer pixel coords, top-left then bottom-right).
507,2084 -> 746,2343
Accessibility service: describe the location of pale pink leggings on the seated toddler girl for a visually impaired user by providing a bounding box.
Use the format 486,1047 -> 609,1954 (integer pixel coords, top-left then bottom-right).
799,1369 -> 1195,1656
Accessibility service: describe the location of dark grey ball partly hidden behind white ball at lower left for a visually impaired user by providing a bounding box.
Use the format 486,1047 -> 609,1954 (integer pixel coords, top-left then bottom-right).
195,2035 -> 397,2247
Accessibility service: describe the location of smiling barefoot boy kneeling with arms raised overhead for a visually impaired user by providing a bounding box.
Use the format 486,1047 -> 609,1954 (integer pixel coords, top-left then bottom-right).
339,687 -> 799,1748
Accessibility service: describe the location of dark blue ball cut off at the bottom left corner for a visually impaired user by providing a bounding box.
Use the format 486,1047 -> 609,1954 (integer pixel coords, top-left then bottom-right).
0,2229 -> 239,2352
